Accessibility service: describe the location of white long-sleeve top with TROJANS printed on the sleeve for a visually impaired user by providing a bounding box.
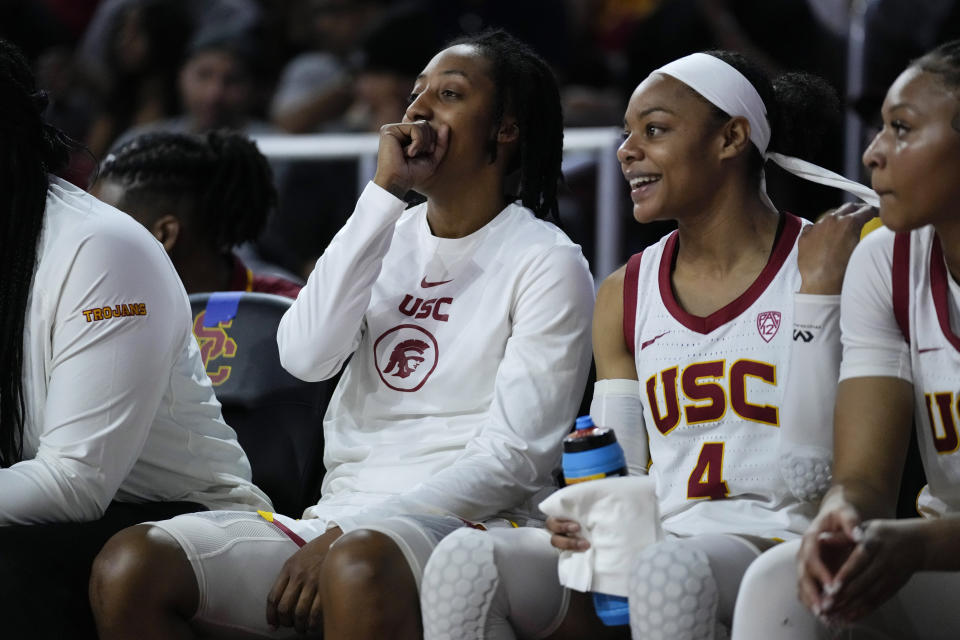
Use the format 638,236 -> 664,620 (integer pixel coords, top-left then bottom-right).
10,179 -> 270,525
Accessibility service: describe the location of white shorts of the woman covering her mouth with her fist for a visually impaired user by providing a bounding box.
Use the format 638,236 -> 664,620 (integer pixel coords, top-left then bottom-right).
149,511 -> 465,638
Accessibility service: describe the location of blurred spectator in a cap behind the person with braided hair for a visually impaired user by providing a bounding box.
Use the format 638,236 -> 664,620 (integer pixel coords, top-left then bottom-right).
114,29 -> 276,146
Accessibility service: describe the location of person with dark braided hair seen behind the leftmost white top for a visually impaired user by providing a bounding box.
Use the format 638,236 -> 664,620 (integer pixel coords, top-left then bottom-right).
91,131 -> 300,298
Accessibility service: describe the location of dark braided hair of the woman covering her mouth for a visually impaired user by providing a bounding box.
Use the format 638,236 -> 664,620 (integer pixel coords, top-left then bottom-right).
451,29 -> 563,224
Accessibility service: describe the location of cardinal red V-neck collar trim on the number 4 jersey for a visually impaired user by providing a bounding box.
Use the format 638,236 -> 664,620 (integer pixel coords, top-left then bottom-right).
659,213 -> 803,334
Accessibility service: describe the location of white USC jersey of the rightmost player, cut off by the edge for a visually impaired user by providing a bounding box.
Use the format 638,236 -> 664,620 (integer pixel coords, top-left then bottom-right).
892,226 -> 960,515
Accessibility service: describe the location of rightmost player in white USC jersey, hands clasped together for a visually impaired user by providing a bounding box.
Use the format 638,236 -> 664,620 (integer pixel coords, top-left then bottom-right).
734,41 -> 960,640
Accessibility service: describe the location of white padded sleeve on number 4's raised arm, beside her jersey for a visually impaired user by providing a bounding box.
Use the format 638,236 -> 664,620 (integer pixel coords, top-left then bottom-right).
779,293 -> 841,502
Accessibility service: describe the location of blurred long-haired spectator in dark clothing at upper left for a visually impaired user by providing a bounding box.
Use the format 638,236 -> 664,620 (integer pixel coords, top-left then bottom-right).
87,0 -> 192,158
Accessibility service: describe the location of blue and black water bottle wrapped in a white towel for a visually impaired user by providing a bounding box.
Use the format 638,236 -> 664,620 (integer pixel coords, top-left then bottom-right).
562,416 -> 630,627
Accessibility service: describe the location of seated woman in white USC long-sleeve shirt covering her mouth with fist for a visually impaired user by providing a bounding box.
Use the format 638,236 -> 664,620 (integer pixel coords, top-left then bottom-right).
93,33 -> 593,639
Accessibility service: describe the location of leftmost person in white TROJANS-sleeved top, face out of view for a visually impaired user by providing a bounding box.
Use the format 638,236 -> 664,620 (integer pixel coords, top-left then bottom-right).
0,40 -> 269,638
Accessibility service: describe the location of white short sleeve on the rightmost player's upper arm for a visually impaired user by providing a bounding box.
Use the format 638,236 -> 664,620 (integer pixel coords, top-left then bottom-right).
840,229 -> 913,382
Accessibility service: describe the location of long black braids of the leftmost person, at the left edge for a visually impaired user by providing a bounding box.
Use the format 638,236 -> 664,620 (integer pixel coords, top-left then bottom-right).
0,39 -> 79,467
